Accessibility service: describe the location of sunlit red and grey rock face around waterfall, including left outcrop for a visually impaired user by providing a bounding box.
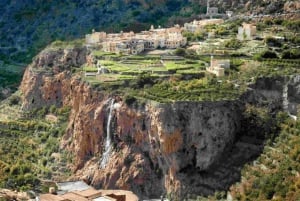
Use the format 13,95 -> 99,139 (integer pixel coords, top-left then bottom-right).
20,47 -> 241,197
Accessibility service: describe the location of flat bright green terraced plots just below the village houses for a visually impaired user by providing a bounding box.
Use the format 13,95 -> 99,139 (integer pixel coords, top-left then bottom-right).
82,51 -> 207,83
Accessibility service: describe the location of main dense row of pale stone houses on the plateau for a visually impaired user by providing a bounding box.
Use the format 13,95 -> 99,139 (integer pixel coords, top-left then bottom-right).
86,25 -> 187,54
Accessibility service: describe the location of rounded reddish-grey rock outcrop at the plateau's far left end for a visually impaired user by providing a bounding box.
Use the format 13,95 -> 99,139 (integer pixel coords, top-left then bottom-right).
20,48 -> 87,110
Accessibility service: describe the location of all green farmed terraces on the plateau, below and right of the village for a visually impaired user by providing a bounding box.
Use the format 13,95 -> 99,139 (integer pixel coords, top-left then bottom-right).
75,20 -> 300,102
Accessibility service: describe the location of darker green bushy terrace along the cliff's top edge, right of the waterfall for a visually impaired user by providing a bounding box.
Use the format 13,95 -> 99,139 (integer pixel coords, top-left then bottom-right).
130,76 -> 245,103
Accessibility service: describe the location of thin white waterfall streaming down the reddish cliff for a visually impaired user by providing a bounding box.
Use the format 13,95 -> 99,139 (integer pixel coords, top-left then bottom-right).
100,99 -> 114,169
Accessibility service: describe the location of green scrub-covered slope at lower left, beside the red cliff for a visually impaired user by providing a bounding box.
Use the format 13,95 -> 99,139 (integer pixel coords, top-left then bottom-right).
0,106 -> 71,191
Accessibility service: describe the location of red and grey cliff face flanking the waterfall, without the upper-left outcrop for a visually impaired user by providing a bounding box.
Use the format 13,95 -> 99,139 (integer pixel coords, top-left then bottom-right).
64,98 -> 242,197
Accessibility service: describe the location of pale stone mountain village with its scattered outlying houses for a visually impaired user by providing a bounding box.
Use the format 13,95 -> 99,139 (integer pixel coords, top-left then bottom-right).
85,4 -> 256,77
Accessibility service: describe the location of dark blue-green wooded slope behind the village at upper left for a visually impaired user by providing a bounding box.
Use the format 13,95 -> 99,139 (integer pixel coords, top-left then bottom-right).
0,0 -> 190,62
